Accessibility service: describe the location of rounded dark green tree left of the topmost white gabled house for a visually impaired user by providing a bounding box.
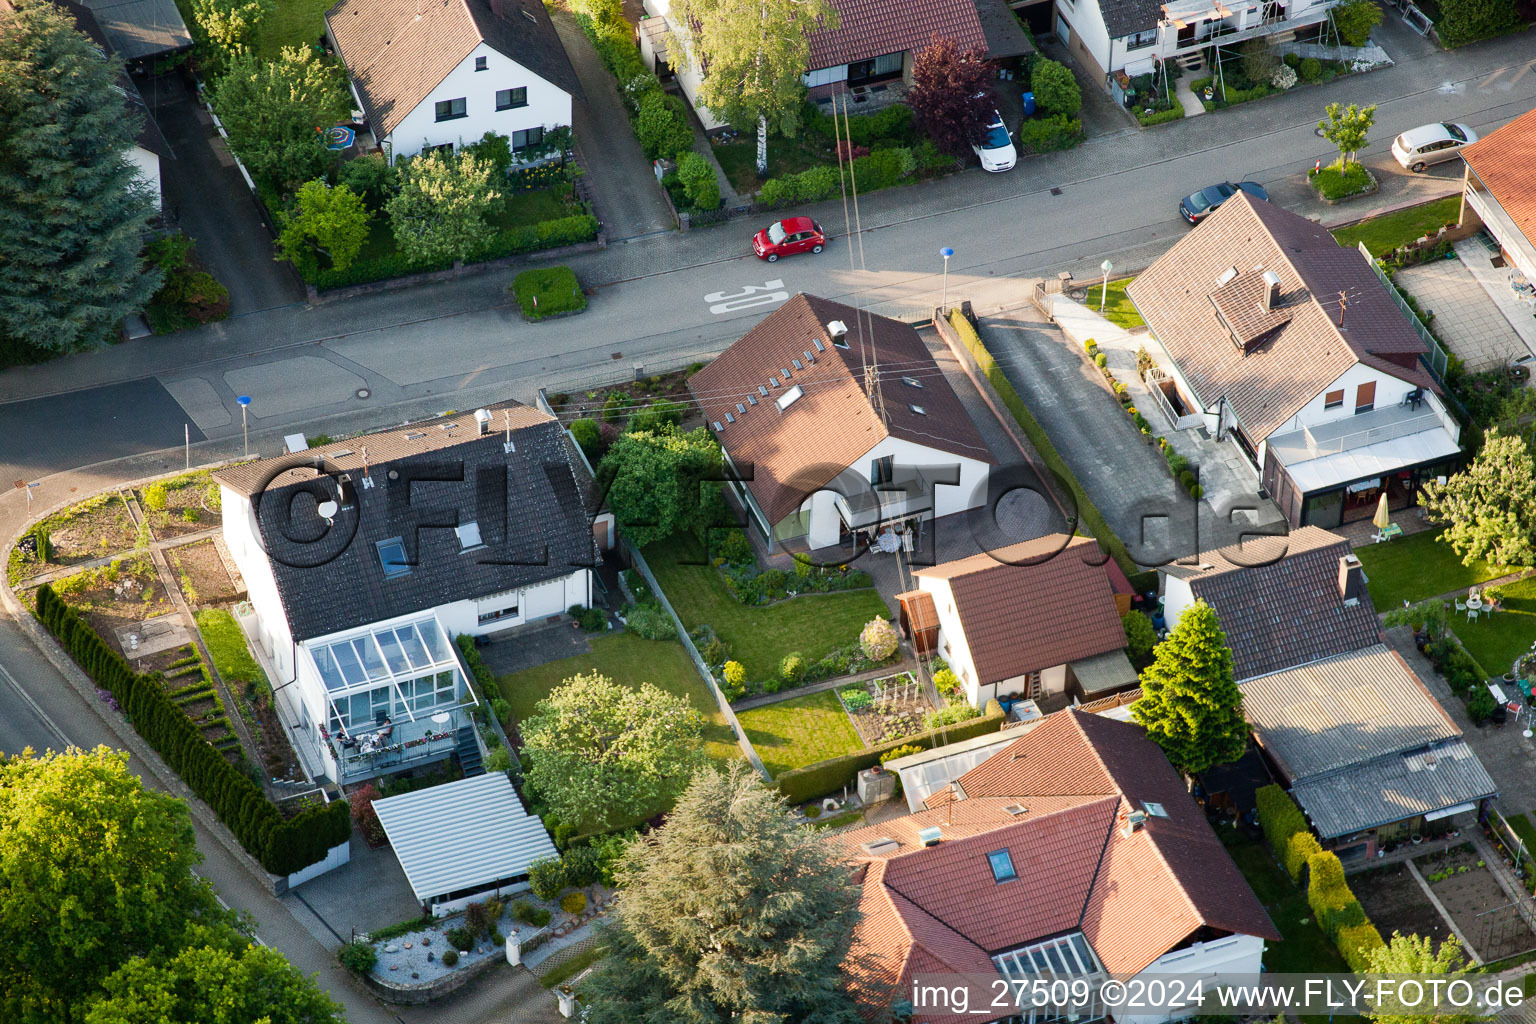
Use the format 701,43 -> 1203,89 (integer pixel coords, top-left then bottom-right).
212,46 -> 352,190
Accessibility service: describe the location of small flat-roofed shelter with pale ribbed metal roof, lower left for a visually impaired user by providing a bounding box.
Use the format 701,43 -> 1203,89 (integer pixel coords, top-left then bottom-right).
373,772 -> 558,917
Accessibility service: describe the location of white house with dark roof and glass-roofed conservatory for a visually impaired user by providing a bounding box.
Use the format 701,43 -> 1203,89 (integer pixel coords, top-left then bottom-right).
214,404 -> 598,781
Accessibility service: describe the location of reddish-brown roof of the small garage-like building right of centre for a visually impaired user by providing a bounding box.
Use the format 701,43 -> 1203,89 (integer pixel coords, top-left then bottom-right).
912,534 -> 1126,686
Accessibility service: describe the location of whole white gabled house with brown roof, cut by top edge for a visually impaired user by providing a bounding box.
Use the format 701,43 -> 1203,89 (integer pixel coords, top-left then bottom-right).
326,0 -> 582,160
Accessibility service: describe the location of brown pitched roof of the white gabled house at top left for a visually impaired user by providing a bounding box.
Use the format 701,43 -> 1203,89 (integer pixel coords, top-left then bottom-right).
326,0 -> 582,138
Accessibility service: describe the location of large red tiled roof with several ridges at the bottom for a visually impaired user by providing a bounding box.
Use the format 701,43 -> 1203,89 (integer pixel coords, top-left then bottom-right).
831,709 -> 1279,1021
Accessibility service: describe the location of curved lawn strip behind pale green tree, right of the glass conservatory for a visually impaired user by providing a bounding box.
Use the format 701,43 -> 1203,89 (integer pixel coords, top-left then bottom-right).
498,633 -> 742,760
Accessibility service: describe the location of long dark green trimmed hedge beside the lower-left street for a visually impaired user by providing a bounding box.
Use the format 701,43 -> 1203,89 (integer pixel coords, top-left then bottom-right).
37,583 -> 352,875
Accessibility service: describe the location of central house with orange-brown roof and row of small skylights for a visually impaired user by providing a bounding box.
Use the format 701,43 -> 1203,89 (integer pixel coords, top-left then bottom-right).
688,293 -> 995,553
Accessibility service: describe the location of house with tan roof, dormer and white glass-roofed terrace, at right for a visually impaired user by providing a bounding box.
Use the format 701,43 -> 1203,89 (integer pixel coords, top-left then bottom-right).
1126,192 -> 1461,528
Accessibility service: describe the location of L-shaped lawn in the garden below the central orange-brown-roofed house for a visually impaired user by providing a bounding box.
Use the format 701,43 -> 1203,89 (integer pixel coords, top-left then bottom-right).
645,534 -> 891,684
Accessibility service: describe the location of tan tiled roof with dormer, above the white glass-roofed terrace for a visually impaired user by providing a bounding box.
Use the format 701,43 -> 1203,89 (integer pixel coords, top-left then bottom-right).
1127,190 -> 1439,444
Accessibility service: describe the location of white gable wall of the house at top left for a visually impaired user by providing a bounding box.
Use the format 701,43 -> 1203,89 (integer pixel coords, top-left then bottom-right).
386,43 -> 571,160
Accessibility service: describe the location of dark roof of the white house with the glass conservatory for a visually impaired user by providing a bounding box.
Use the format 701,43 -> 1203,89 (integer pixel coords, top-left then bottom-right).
214,402 -> 598,640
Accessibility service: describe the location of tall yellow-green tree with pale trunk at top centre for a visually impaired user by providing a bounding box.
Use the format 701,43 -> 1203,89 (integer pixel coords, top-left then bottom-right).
668,0 -> 839,177
